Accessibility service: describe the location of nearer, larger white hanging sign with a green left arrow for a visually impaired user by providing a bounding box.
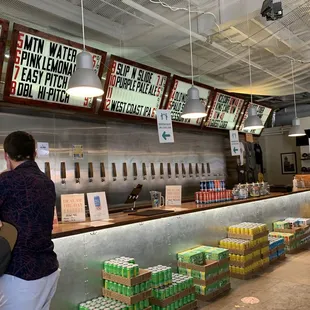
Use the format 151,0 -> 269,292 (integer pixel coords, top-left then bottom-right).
156,110 -> 174,143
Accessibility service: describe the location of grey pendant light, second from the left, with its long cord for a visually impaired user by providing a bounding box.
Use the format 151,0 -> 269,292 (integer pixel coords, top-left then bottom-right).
181,0 -> 207,118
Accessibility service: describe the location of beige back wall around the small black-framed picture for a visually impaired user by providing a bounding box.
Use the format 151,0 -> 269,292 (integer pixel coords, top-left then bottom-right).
259,126 -> 300,185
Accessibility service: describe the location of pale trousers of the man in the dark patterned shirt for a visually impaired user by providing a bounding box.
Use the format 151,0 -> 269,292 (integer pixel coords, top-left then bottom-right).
0,270 -> 60,310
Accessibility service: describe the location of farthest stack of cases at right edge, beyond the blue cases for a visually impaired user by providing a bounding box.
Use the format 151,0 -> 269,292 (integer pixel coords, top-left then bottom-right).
269,218 -> 310,254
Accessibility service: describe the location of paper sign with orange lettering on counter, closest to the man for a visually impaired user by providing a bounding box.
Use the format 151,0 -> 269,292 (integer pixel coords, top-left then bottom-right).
61,194 -> 86,223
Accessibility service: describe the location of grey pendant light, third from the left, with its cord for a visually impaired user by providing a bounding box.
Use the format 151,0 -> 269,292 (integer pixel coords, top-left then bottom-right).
243,17 -> 264,130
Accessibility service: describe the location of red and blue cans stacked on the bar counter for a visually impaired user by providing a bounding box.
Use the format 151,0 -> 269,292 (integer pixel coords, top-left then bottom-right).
195,180 -> 232,204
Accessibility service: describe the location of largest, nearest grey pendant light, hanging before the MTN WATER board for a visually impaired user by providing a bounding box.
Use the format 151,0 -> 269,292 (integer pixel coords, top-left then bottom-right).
67,0 -> 103,98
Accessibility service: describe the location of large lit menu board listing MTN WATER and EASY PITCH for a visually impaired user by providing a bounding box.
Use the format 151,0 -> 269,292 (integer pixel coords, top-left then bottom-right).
4,24 -> 106,111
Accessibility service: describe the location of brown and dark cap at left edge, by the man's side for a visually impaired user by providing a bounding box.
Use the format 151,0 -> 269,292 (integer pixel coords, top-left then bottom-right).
0,222 -> 17,276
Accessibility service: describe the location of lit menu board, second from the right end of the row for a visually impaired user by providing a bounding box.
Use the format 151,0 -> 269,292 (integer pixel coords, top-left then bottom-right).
205,92 -> 244,130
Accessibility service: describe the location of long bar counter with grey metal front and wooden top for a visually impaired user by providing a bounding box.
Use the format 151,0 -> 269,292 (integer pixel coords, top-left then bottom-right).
51,190 -> 310,310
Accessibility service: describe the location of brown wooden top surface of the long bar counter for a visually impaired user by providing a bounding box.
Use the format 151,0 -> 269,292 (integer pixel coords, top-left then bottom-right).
53,189 -> 309,239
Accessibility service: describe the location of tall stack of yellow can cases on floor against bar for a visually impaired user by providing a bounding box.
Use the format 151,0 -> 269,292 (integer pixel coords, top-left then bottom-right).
220,223 -> 269,280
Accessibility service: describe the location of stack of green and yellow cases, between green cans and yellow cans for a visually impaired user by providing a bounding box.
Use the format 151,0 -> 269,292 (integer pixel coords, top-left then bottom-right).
177,246 -> 230,301
